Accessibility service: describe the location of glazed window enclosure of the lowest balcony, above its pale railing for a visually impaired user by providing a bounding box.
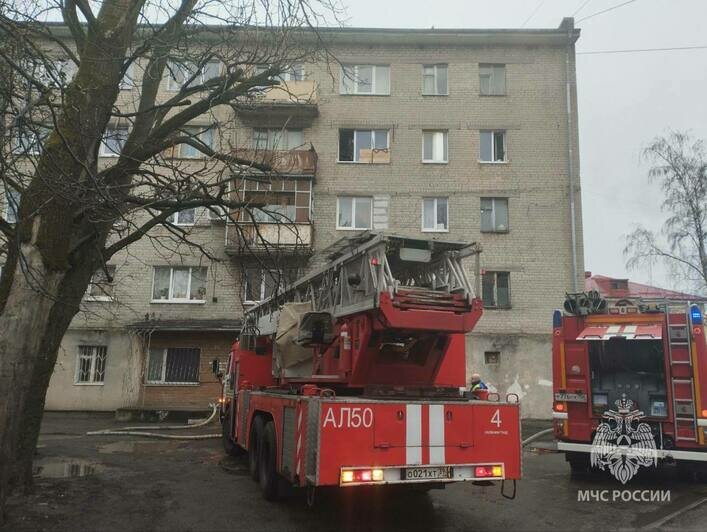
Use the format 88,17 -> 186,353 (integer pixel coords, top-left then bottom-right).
234,179 -> 312,223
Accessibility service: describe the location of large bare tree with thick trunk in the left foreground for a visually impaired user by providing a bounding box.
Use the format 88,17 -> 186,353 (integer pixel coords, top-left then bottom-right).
0,0 -> 340,516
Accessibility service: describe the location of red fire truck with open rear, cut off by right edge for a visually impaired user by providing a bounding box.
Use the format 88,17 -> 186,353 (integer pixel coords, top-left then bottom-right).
552,292 -> 707,476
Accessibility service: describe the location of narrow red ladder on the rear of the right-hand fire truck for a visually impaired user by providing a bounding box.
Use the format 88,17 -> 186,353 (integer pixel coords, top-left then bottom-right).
665,310 -> 698,441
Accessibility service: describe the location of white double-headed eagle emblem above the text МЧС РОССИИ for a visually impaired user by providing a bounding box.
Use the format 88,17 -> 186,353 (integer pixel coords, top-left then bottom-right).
591,395 -> 658,484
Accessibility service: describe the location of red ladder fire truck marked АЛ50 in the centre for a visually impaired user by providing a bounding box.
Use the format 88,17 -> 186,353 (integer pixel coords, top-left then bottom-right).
221,233 -> 521,500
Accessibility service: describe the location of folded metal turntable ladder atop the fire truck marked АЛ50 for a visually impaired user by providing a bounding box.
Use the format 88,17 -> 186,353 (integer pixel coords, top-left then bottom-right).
243,233 -> 481,336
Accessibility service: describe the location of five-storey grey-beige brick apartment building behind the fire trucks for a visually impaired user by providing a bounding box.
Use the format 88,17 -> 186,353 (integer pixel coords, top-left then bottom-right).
5,19 -> 584,417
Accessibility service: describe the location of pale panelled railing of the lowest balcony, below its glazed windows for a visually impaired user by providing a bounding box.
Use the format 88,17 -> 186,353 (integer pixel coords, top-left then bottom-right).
226,223 -> 312,255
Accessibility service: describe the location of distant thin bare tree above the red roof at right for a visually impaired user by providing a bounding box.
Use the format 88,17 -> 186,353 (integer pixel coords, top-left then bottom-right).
624,132 -> 707,292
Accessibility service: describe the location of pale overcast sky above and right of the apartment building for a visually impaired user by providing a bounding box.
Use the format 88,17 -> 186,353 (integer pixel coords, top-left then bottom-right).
344,0 -> 707,288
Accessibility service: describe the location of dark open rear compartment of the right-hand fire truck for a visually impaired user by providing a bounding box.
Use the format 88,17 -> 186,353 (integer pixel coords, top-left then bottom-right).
589,337 -> 668,417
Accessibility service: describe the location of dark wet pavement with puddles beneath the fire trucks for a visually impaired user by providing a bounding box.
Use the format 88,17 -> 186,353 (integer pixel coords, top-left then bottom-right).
4,413 -> 707,532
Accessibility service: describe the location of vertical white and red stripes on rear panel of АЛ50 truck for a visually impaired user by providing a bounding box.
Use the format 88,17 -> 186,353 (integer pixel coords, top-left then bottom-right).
405,403 -> 446,465
